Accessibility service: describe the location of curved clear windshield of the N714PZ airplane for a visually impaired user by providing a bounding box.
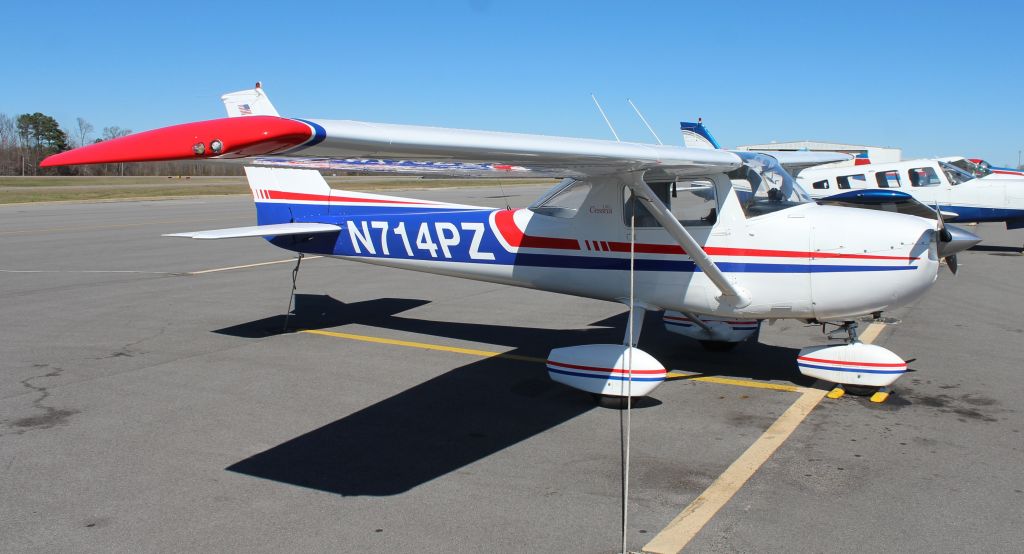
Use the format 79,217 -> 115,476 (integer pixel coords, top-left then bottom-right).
730,152 -> 811,217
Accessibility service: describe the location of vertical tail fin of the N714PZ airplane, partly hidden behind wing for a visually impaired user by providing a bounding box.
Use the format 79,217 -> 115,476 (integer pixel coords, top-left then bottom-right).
220,83 -> 331,225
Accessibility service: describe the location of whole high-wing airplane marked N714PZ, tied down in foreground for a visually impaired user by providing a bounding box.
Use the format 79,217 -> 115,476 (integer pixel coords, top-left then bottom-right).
42,85 -> 978,396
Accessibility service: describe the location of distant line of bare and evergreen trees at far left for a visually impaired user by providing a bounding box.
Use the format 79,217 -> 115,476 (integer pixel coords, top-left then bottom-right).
0,112 -> 243,176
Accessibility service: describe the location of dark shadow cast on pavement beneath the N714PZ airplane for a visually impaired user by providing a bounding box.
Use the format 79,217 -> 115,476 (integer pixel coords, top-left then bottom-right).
226,295 -> 796,496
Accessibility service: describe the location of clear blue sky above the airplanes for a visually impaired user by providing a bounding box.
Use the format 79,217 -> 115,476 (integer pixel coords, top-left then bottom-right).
8,0 -> 1024,164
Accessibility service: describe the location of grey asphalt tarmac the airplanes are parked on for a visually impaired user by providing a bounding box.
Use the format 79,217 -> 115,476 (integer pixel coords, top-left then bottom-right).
0,186 -> 1024,552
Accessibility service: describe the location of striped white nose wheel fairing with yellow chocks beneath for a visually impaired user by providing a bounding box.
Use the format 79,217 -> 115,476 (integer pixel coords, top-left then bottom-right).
797,342 -> 906,387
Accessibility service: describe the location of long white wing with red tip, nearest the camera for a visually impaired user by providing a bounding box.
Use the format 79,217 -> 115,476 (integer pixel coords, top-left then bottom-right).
40,116 -> 741,178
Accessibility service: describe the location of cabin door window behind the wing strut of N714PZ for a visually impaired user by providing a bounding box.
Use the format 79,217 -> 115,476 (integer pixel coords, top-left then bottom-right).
623,180 -> 718,228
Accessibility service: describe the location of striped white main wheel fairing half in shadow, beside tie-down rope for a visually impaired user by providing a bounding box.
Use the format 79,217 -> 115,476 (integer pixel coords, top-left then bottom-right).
548,344 -> 667,396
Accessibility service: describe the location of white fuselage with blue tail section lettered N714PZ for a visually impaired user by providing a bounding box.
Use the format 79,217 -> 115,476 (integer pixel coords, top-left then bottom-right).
256,175 -> 938,319
